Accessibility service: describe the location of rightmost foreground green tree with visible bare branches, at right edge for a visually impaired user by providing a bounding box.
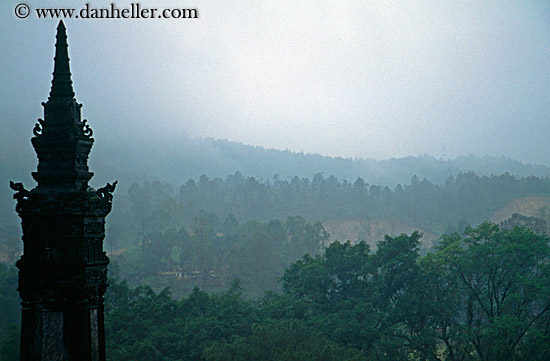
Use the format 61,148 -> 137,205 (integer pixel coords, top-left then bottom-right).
425,223 -> 550,361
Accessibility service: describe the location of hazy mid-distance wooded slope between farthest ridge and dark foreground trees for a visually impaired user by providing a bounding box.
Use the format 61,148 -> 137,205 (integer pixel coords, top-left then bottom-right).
4,172 -> 550,297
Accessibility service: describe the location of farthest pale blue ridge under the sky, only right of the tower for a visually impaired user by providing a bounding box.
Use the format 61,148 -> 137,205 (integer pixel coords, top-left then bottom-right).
91,138 -> 550,188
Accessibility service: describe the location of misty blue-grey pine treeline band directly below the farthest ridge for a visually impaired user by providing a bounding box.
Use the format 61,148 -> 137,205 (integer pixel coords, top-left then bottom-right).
107,172 -> 550,244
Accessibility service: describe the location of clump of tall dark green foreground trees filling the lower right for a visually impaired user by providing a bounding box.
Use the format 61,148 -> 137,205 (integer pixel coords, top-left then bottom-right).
283,223 -> 550,361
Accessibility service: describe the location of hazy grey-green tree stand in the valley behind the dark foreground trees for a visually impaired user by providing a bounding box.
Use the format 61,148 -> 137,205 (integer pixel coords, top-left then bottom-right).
111,212 -> 329,298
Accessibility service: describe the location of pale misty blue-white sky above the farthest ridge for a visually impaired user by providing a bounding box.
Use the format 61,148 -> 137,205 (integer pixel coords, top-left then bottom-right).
0,0 -> 550,165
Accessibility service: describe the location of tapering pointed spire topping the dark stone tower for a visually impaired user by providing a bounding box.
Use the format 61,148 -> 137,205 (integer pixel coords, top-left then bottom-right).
49,20 -> 74,100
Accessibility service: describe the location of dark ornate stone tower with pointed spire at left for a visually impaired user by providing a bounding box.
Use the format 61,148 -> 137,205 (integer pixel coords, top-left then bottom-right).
10,21 -> 116,361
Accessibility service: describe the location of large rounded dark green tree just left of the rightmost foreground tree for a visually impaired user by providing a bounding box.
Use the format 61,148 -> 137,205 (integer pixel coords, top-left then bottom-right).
282,232 -> 435,360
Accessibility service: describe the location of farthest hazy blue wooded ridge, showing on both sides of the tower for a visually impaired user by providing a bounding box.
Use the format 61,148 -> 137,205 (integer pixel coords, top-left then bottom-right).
0,141 -> 550,228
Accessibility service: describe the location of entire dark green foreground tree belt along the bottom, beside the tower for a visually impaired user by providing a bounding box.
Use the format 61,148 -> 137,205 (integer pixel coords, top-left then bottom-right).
0,223 -> 550,361
